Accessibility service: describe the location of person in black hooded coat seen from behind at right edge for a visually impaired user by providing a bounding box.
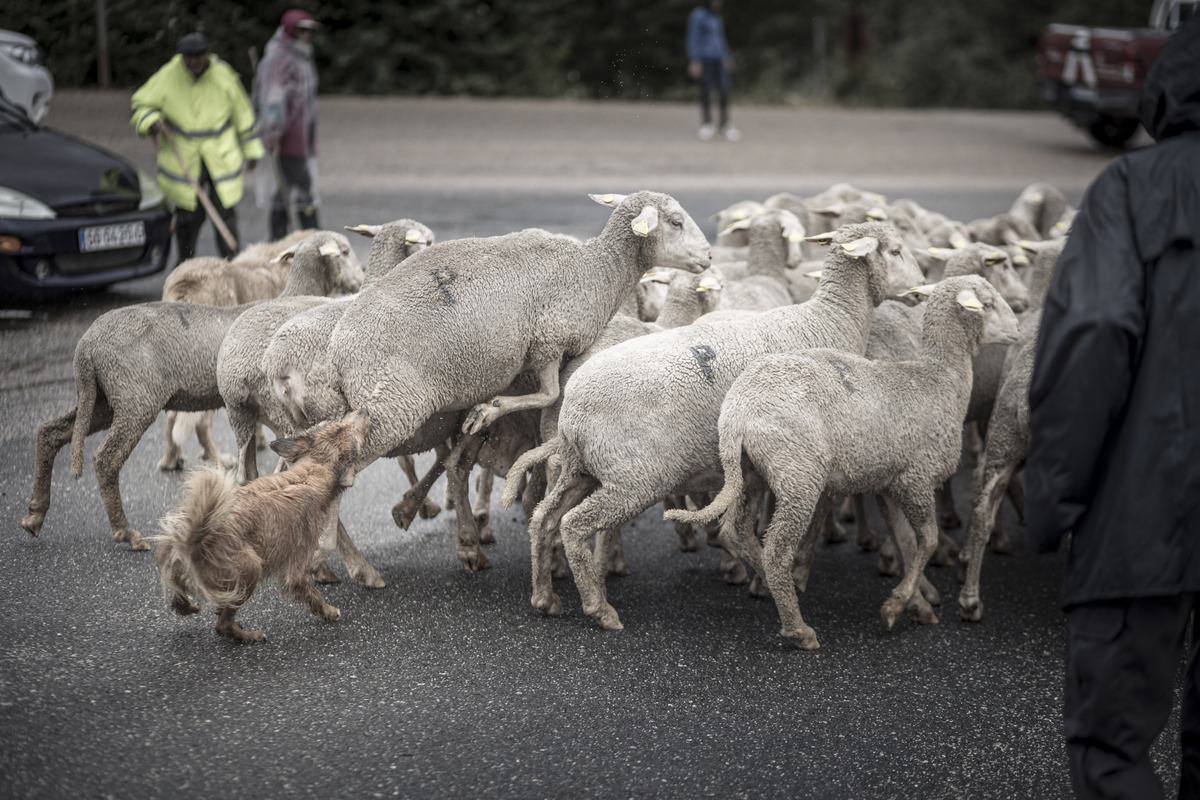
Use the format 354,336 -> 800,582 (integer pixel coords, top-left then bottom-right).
1025,17 -> 1200,798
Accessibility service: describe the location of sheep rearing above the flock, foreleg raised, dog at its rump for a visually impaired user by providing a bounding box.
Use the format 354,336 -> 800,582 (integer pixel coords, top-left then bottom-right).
265,192 -> 710,570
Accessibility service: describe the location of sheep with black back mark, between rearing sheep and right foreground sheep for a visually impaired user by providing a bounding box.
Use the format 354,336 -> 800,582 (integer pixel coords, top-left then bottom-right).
511,223 -> 922,628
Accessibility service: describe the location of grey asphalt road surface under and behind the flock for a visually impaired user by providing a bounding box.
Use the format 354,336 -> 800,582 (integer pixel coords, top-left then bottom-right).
0,92 -> 1178,799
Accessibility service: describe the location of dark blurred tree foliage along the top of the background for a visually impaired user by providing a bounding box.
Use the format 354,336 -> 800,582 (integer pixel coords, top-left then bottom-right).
0,0 -> 1150,108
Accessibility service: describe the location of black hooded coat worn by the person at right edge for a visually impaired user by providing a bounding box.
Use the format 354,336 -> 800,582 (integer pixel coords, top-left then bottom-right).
1025,17 -> 1200,607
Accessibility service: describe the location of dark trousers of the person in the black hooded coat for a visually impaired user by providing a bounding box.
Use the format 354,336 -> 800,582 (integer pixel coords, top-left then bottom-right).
1064,595 -> 1200,800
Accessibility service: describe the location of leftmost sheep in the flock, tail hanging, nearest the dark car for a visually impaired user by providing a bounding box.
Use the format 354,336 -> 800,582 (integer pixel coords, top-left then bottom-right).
20,233 -> 362,551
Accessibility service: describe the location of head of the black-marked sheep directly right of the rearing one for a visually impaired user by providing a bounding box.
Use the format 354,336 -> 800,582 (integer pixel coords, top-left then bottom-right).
805,222 -> 925,306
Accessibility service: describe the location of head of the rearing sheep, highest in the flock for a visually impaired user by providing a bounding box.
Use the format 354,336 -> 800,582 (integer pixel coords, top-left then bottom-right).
589,192 -> 713,272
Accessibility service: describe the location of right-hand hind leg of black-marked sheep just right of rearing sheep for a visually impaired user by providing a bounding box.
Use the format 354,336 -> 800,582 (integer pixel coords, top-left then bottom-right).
559,486 -> 643,631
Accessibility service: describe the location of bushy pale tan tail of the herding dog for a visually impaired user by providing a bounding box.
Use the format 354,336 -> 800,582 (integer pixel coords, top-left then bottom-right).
150,467 -> 258,610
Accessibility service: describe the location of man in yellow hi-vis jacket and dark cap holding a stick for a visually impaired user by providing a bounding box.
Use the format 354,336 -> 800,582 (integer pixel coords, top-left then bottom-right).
132,34 -> 264,263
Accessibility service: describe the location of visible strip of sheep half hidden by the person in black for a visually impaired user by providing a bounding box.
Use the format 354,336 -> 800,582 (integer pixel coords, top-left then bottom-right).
959,311 -> 1042,622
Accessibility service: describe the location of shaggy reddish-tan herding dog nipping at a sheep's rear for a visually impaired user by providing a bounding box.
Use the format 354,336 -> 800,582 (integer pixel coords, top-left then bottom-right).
152,410 -> 371,642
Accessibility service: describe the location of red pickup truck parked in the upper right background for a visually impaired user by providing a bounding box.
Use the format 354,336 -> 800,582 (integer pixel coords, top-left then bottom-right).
1038,0 -> 1200,148
